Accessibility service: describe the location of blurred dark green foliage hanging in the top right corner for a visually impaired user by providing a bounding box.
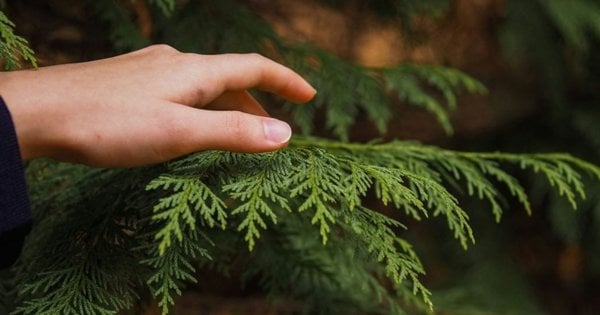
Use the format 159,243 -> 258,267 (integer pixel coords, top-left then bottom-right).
500,0 -> 600,110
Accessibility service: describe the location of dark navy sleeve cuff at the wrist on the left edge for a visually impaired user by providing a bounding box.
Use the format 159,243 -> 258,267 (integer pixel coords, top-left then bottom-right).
0,97 -> 31,269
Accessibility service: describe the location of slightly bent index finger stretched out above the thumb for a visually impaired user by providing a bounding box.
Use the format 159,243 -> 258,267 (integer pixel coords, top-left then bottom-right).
200,54 -> 316,103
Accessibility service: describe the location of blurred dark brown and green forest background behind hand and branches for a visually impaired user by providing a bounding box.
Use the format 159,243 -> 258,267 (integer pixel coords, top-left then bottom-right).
3,0 -> 600,314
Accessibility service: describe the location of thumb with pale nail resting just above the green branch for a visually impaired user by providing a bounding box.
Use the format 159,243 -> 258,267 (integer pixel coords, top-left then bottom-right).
193,110 -> 292,153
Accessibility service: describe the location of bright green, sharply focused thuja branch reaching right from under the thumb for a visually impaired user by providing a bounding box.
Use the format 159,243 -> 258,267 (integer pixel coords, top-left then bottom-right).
144,137 -> 600,314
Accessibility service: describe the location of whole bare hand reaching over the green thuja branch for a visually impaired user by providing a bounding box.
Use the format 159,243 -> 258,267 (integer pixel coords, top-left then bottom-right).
0,45 -> 315,167
